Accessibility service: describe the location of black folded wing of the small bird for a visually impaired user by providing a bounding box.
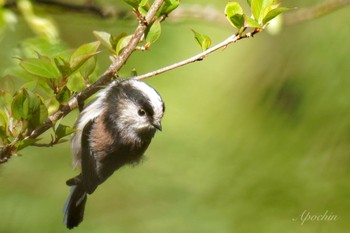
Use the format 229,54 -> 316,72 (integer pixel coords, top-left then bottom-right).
81,119 -> 99,194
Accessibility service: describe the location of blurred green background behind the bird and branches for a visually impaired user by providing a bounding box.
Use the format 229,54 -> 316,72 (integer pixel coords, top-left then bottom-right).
0,0 -> 350,233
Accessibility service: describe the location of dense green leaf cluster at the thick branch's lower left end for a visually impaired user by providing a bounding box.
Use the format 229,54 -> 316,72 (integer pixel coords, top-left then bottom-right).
0,41 -> 100,155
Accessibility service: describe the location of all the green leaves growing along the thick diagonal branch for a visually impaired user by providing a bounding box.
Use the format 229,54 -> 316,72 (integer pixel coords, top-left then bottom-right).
0,0 -> 180,157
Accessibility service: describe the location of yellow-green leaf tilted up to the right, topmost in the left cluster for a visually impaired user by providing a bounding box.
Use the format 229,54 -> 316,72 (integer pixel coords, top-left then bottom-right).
69,41 -> 101,72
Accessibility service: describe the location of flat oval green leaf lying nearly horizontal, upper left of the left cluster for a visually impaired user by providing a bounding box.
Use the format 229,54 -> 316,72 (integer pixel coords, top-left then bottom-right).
19,58 -> 61,79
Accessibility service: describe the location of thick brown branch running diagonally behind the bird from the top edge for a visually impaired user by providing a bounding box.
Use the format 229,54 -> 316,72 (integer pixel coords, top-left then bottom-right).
0,0 -> 164,163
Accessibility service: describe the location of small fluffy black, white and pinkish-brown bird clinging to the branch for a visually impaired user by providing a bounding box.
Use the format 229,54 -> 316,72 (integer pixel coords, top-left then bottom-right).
64,79 -> 165,229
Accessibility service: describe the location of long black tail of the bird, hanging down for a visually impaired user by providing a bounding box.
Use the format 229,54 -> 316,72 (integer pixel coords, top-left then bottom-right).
63,185 -> 87,229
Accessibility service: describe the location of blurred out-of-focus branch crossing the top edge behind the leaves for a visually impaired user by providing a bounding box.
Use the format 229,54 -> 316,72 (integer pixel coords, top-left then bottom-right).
3,0 -> 350,25
